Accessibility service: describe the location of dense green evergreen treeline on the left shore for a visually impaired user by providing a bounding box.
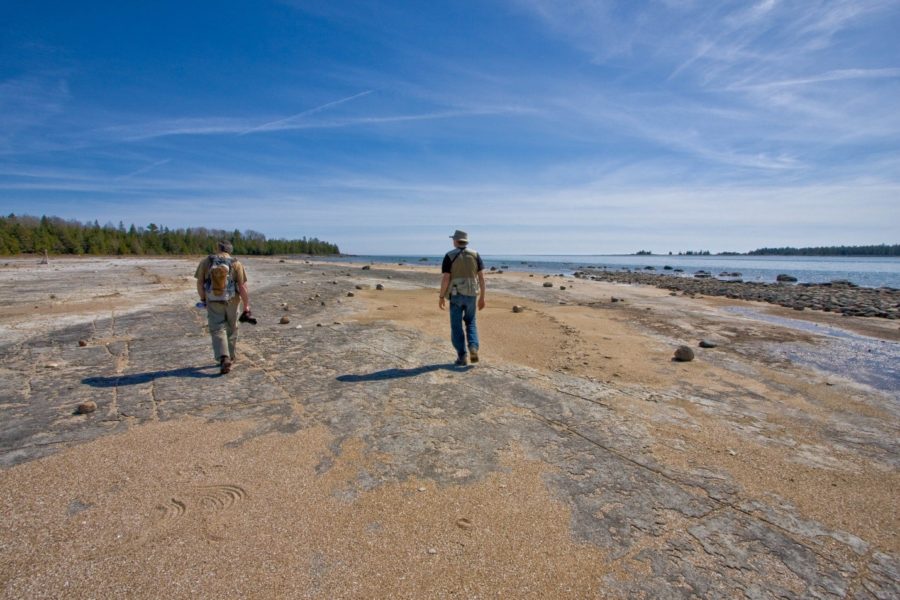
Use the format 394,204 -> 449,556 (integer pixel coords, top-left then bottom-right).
0,214 -> 340,256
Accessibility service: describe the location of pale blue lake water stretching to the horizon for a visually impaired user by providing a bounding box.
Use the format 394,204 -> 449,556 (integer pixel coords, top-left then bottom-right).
322,254 -> 900,288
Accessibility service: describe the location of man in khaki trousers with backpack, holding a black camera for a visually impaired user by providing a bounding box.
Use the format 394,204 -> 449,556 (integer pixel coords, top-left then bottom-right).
194,241 -> 255,375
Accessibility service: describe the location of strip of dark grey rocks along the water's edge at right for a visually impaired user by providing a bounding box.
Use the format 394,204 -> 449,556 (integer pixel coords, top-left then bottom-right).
574,269 -> 900,320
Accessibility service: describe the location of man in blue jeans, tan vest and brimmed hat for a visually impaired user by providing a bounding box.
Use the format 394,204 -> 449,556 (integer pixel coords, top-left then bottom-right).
438,229 -> 484,366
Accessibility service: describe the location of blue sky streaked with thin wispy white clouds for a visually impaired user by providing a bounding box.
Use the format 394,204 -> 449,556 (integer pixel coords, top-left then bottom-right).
0,0 -> 900,254
